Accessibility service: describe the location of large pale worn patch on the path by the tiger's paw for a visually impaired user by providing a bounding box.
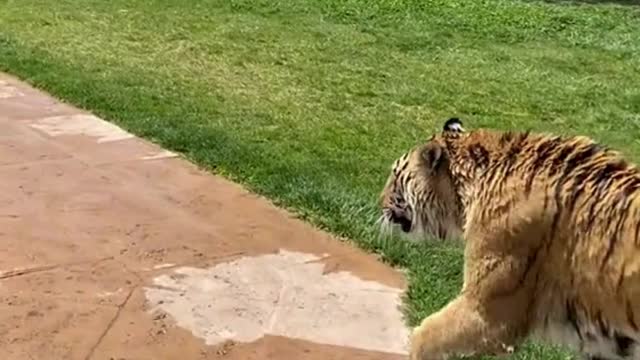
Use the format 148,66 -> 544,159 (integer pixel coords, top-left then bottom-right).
145,250 -> 408,354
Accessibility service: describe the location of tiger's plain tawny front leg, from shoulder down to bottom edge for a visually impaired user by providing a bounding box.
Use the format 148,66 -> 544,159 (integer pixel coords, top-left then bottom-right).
410,186 -> 554,360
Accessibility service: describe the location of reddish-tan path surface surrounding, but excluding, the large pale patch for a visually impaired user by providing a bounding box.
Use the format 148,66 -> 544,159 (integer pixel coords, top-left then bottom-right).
0,74 -> 404,360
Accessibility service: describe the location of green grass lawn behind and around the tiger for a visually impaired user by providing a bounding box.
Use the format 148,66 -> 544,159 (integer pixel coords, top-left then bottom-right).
0,0 -> 640,359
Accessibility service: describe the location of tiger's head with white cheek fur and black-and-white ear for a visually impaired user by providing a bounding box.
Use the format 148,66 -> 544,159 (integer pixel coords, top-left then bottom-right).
380,118 -> 464,240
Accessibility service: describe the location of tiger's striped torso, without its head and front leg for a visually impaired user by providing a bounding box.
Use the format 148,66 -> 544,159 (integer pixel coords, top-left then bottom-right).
460,129 -> 640,359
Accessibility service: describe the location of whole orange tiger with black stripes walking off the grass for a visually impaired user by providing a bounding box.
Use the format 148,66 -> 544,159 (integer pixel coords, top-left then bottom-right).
380,118 -> 640,360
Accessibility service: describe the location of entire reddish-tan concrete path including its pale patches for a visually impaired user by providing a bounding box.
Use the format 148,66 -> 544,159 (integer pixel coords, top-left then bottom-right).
0,74 -> 408,360
